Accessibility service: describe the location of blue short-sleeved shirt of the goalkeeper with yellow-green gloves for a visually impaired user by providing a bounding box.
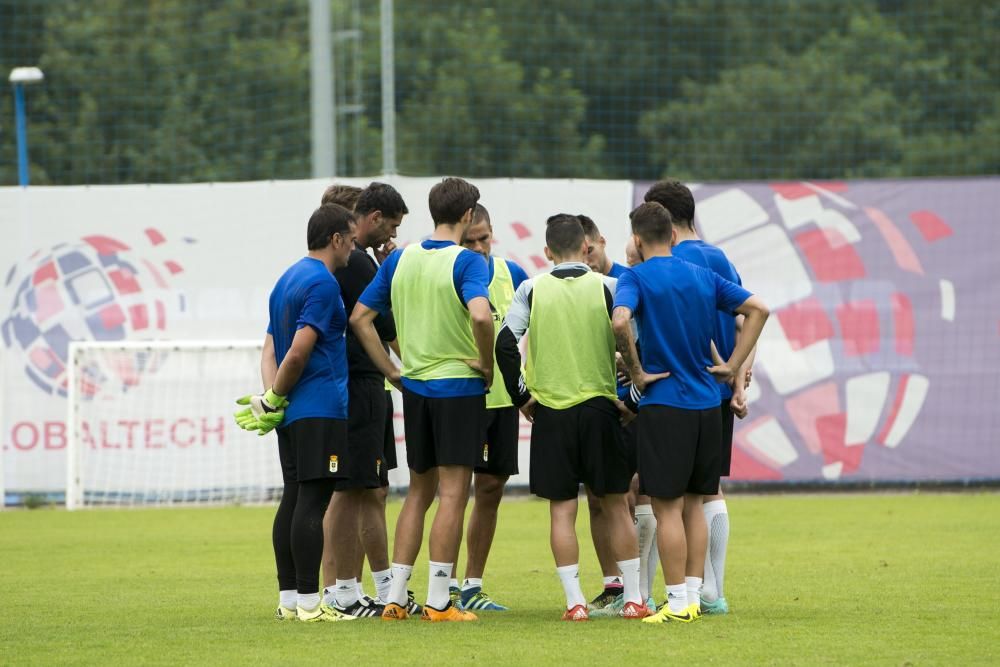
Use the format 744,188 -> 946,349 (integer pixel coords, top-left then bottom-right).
267,257 -> 347,426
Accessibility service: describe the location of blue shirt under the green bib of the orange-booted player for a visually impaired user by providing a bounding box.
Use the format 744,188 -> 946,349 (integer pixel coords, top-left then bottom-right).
358,239 -> 490,398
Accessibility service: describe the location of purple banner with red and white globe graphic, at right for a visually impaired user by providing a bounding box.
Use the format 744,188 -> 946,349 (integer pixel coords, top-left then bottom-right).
634,179 -> 1000,481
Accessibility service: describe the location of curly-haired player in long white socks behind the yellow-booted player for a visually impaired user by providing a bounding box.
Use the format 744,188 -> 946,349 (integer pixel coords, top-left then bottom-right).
645,179 -> 754,614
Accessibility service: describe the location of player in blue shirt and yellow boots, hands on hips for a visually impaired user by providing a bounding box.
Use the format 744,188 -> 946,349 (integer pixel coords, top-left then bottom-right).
613,202 -> 768,623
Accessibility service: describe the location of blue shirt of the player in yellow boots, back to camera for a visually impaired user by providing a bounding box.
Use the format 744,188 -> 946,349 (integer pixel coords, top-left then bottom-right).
615,257 -> 751,410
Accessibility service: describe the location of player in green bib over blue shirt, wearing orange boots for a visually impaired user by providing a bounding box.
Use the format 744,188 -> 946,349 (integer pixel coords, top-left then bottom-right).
351,178 -> 494,621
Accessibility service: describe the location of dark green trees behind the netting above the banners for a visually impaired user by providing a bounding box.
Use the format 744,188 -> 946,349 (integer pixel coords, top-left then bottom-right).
0,0 -> 1000,184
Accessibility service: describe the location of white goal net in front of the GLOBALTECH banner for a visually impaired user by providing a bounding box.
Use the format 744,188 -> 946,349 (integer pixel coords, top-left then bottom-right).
66,341 -> 282,509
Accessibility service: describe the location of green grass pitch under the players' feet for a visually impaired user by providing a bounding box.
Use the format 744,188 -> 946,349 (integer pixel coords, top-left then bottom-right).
0,494 -> 1000,665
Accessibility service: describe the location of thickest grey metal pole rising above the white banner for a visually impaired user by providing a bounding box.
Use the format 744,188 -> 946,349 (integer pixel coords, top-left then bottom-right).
309,0 -> 337,178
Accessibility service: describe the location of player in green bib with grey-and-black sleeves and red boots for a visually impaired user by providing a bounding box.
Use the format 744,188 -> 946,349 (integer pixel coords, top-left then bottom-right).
497,214 -> 649,621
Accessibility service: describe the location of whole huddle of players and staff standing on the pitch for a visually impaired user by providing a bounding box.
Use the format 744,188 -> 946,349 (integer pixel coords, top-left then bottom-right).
236,178 -> 768,622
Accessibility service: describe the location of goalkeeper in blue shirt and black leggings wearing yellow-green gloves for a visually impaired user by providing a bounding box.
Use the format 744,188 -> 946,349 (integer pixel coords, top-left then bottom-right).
237,204 -> 355,622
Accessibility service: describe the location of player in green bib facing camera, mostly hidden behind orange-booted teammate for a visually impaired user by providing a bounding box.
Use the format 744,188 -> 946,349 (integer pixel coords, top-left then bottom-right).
451,204 -> 528,611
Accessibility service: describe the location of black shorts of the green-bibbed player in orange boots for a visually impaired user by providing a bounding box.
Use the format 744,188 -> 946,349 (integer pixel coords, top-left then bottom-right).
403,388 -> 486,473
